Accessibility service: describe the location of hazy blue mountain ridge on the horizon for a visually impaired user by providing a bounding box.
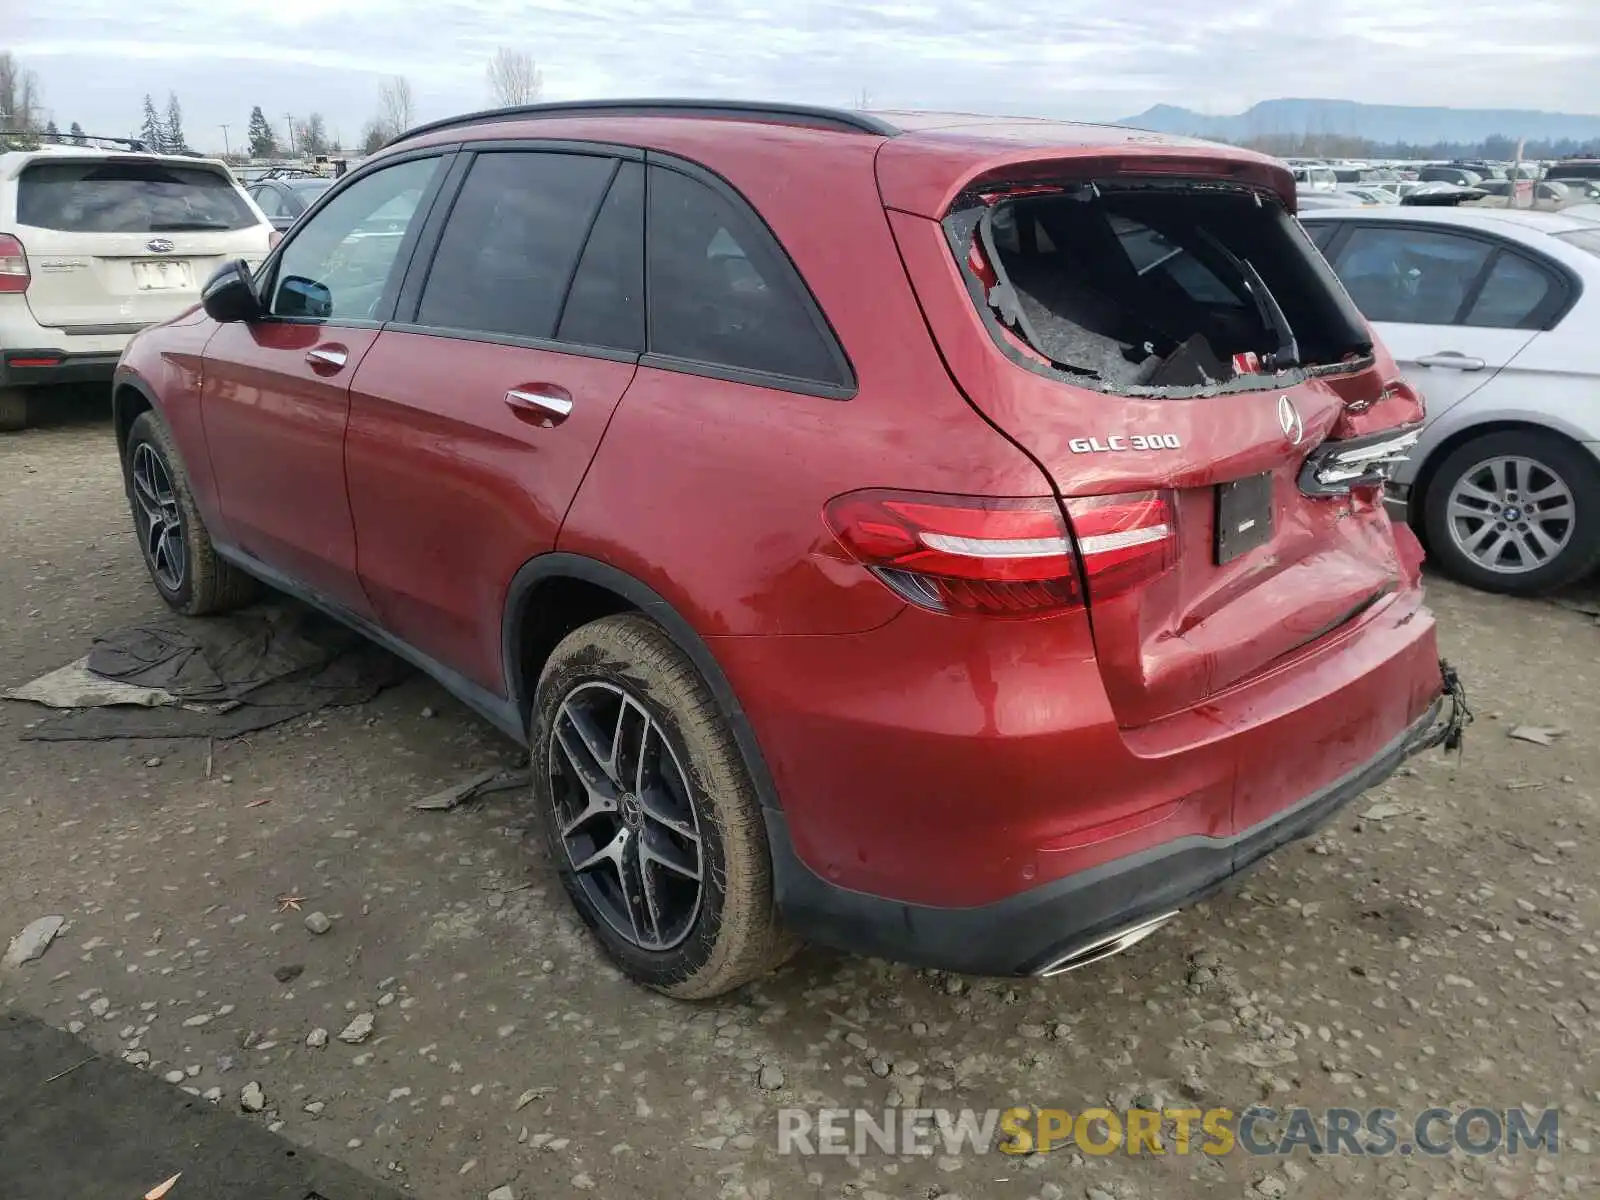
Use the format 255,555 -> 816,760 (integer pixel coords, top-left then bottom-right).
1120,99 -> 1600,146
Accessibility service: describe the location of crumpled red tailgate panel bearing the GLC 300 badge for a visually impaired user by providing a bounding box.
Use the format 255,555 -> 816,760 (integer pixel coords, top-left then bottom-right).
890,213 -> 1427,726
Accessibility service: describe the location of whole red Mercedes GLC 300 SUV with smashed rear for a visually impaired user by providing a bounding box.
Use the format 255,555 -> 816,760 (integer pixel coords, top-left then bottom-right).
115,101 -> 1462,997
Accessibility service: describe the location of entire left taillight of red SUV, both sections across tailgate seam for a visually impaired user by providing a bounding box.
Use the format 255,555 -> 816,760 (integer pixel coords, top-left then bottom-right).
826,490 -> 1178,616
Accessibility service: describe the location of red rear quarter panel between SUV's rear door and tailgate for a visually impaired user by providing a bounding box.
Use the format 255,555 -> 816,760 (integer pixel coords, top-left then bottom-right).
557,120 -> 1050,637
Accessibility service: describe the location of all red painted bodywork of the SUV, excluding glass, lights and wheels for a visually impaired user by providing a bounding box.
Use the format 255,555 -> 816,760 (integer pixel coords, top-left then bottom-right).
123,115 -> 1442,947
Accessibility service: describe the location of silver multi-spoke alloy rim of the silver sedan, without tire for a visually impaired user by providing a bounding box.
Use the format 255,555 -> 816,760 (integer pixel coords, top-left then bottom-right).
1445,456 -> 1578,574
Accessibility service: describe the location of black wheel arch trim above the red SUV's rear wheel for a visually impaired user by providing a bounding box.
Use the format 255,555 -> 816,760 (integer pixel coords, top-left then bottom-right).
501,550 -> 782,810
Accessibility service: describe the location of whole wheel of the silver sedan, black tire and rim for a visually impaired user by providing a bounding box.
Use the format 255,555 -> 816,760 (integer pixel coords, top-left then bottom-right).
1422,429 -> 1600,595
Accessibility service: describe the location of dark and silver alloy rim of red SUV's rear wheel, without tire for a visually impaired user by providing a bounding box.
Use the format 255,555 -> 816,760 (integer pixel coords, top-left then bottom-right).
549,682 -> 706,952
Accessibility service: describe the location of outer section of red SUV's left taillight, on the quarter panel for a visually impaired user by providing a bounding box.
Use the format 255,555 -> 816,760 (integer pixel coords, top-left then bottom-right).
826,490 -> 1082,618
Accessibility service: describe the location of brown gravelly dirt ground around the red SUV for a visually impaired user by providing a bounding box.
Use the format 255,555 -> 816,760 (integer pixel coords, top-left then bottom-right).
0,396 -> 1600,1200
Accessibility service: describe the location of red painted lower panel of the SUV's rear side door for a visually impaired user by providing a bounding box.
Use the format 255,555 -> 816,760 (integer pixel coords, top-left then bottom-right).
346,330 -> 636,694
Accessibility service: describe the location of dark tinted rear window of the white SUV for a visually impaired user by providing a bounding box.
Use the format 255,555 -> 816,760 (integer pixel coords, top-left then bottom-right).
16,162 -> 258,234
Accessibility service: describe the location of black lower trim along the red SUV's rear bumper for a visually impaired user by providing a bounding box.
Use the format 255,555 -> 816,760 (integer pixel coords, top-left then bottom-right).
766,698 -> 1454,976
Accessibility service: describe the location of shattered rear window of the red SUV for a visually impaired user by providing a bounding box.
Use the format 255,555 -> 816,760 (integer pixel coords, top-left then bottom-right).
946,181 -> 1371,394
